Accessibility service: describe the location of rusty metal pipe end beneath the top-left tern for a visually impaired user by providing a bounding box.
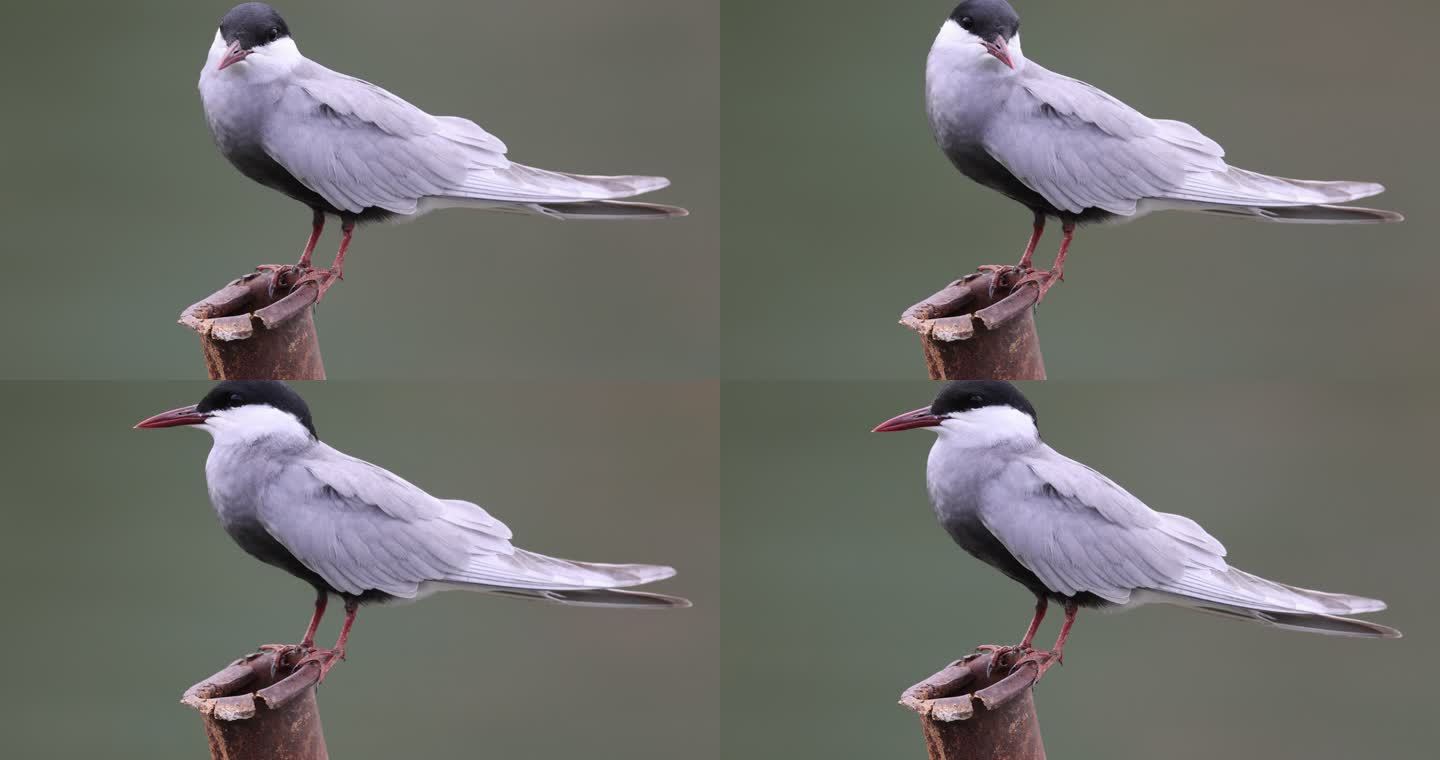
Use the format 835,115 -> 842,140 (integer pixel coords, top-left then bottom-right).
180,272 -> 325,380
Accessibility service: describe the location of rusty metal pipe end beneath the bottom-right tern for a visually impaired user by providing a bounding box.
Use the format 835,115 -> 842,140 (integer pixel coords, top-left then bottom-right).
900,653 -> 1045,760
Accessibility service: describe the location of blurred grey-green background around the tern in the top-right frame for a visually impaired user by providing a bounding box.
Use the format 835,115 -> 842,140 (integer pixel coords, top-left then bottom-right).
723,0 -> 1440,380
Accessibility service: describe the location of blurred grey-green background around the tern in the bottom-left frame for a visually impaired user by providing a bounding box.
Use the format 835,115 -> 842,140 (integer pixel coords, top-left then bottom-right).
0,381 -> 720,759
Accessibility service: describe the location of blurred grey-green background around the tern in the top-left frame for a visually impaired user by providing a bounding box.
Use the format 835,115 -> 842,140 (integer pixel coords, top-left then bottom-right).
0,0 -> 720,380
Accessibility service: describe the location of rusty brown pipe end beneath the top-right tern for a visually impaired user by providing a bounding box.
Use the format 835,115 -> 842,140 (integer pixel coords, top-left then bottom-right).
900,272 -> 1045,380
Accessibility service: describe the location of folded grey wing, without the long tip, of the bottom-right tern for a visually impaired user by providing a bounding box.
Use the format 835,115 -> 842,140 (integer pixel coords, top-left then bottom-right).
981,446 -> 1225,605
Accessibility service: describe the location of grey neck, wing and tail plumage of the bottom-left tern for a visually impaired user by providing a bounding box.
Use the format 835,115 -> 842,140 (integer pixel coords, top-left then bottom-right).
206,435 -> 684,606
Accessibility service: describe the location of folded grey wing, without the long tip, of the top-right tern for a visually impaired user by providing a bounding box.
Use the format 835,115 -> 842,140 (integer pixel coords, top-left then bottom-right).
984,62 -> 1227,216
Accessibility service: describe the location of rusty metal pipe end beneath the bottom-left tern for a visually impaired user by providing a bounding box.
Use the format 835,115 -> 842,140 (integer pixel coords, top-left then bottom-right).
180,652 -> 330,760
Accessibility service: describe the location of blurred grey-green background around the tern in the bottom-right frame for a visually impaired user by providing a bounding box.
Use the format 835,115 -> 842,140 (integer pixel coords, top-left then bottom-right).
721,381 -> 1440,760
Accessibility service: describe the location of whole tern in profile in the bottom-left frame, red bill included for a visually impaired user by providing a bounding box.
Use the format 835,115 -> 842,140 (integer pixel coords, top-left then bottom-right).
135,381 -> 690,678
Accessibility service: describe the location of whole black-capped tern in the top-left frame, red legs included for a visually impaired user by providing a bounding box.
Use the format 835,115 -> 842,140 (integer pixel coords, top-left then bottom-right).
200,3 -> 685,295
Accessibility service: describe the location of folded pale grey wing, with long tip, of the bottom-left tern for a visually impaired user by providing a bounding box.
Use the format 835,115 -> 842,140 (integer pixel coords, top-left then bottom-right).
259,443 -> 674,600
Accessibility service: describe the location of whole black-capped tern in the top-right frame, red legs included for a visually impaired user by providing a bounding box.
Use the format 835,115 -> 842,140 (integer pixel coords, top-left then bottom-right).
924,0 -> 1403,297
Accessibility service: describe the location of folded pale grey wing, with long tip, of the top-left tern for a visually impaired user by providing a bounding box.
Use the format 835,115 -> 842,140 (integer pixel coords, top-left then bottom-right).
264,62 -> 668,214
